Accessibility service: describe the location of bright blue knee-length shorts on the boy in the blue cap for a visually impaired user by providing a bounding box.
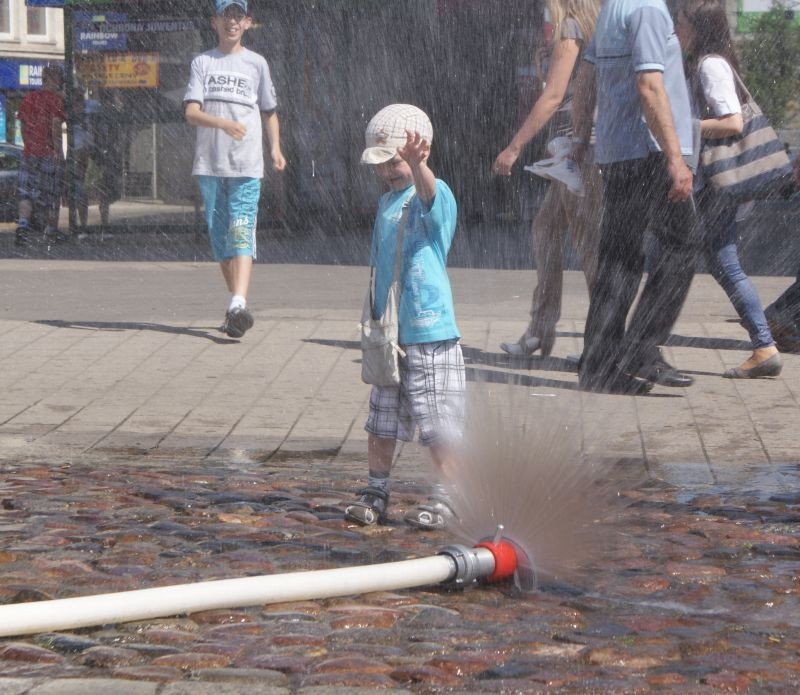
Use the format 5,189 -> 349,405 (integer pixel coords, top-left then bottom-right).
197,176 -> 261,261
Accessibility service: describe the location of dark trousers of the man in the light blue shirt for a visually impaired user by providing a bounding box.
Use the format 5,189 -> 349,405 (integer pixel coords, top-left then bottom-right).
581,153 -> 696,382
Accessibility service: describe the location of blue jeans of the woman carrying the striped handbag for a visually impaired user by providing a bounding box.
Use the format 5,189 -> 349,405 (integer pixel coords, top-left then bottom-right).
697,189 -> 775,349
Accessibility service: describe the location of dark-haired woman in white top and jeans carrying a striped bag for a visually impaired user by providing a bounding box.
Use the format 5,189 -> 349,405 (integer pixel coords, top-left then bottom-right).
676,0 -> 782,379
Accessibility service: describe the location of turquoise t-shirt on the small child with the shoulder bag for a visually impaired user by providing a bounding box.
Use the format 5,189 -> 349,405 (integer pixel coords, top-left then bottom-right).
370,179 -> 461,345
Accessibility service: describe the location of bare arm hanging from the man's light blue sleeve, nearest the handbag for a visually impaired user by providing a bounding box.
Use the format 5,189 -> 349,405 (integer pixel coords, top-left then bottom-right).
636,70 -> 692,202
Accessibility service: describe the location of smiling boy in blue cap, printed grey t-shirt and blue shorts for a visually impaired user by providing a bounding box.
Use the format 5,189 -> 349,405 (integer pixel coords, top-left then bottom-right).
184,0 -> 286,338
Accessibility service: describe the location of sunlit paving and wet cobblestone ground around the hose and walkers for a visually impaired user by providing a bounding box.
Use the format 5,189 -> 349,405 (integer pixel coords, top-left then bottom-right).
0,259 -> 800,695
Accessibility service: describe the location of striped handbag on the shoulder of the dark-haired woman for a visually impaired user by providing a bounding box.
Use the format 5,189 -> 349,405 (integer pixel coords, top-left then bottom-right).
700,56 -> 795,203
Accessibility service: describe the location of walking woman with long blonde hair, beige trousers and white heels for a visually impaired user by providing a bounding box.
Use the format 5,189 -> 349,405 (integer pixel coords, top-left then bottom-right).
492,0 -> 602,356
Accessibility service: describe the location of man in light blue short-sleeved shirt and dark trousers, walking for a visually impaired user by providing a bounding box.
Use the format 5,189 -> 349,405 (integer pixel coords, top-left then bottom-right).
573,0 -> 697,394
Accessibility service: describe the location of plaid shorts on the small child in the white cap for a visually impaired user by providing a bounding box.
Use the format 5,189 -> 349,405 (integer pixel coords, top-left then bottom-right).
364,340 -> 466,446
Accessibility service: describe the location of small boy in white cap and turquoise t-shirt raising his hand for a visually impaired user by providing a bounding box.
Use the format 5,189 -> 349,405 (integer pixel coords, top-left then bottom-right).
345,104 -> 465,529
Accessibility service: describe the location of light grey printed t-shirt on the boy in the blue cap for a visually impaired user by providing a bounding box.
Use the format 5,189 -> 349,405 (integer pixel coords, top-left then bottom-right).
184,48 -> 277,179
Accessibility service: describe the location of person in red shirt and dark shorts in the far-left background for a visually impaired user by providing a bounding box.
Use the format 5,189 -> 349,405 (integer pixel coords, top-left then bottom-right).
14,65 -> 67,246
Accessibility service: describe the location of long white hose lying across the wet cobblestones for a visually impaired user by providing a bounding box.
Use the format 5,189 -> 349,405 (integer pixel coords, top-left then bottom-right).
0,551 -> 456,637
